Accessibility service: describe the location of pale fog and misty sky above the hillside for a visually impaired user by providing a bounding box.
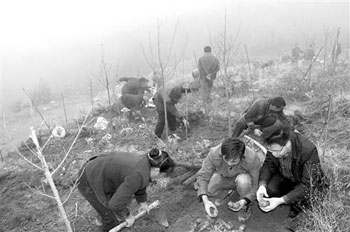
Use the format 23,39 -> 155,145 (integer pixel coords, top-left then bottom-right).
0,0 -> 349,112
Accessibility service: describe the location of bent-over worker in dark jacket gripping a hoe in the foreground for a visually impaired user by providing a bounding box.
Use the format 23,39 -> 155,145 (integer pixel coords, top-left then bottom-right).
78,148 -> 174,232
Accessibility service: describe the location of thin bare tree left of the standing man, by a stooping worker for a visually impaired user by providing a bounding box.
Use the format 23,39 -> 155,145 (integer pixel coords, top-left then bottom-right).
141,20 -> 187,140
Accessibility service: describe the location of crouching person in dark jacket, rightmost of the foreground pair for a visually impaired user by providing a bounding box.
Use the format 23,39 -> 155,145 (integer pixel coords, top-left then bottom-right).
256,129 -> 327,218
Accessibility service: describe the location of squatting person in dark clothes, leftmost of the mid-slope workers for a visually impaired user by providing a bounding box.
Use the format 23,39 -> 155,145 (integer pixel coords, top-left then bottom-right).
119,77 -> 151,114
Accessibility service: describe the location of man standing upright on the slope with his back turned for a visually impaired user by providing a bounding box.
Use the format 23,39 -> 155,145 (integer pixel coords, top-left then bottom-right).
198,46 -> 220,103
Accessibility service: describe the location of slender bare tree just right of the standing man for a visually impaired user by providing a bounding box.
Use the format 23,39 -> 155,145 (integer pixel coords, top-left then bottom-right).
209,9 -> 242,136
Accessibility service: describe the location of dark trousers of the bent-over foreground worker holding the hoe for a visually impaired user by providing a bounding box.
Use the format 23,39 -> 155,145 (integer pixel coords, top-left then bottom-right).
78,170 -> 120,232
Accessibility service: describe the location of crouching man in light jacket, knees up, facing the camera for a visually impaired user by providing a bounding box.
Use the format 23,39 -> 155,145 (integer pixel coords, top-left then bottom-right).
197,138 -> 261,222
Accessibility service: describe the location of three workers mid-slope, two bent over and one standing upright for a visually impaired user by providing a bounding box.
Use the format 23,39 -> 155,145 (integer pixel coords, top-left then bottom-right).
119,46 -> 220,138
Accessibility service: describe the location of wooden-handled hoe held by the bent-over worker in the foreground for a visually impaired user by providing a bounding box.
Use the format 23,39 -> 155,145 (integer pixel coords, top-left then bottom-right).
109,200 -> 169,232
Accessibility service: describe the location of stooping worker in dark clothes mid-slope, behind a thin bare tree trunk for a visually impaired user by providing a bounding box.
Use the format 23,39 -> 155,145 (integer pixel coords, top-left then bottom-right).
153,86 -> 191,138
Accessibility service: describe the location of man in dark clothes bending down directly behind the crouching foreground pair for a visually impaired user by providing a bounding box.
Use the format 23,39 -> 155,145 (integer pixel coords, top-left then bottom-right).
232,97 -> 291,138
